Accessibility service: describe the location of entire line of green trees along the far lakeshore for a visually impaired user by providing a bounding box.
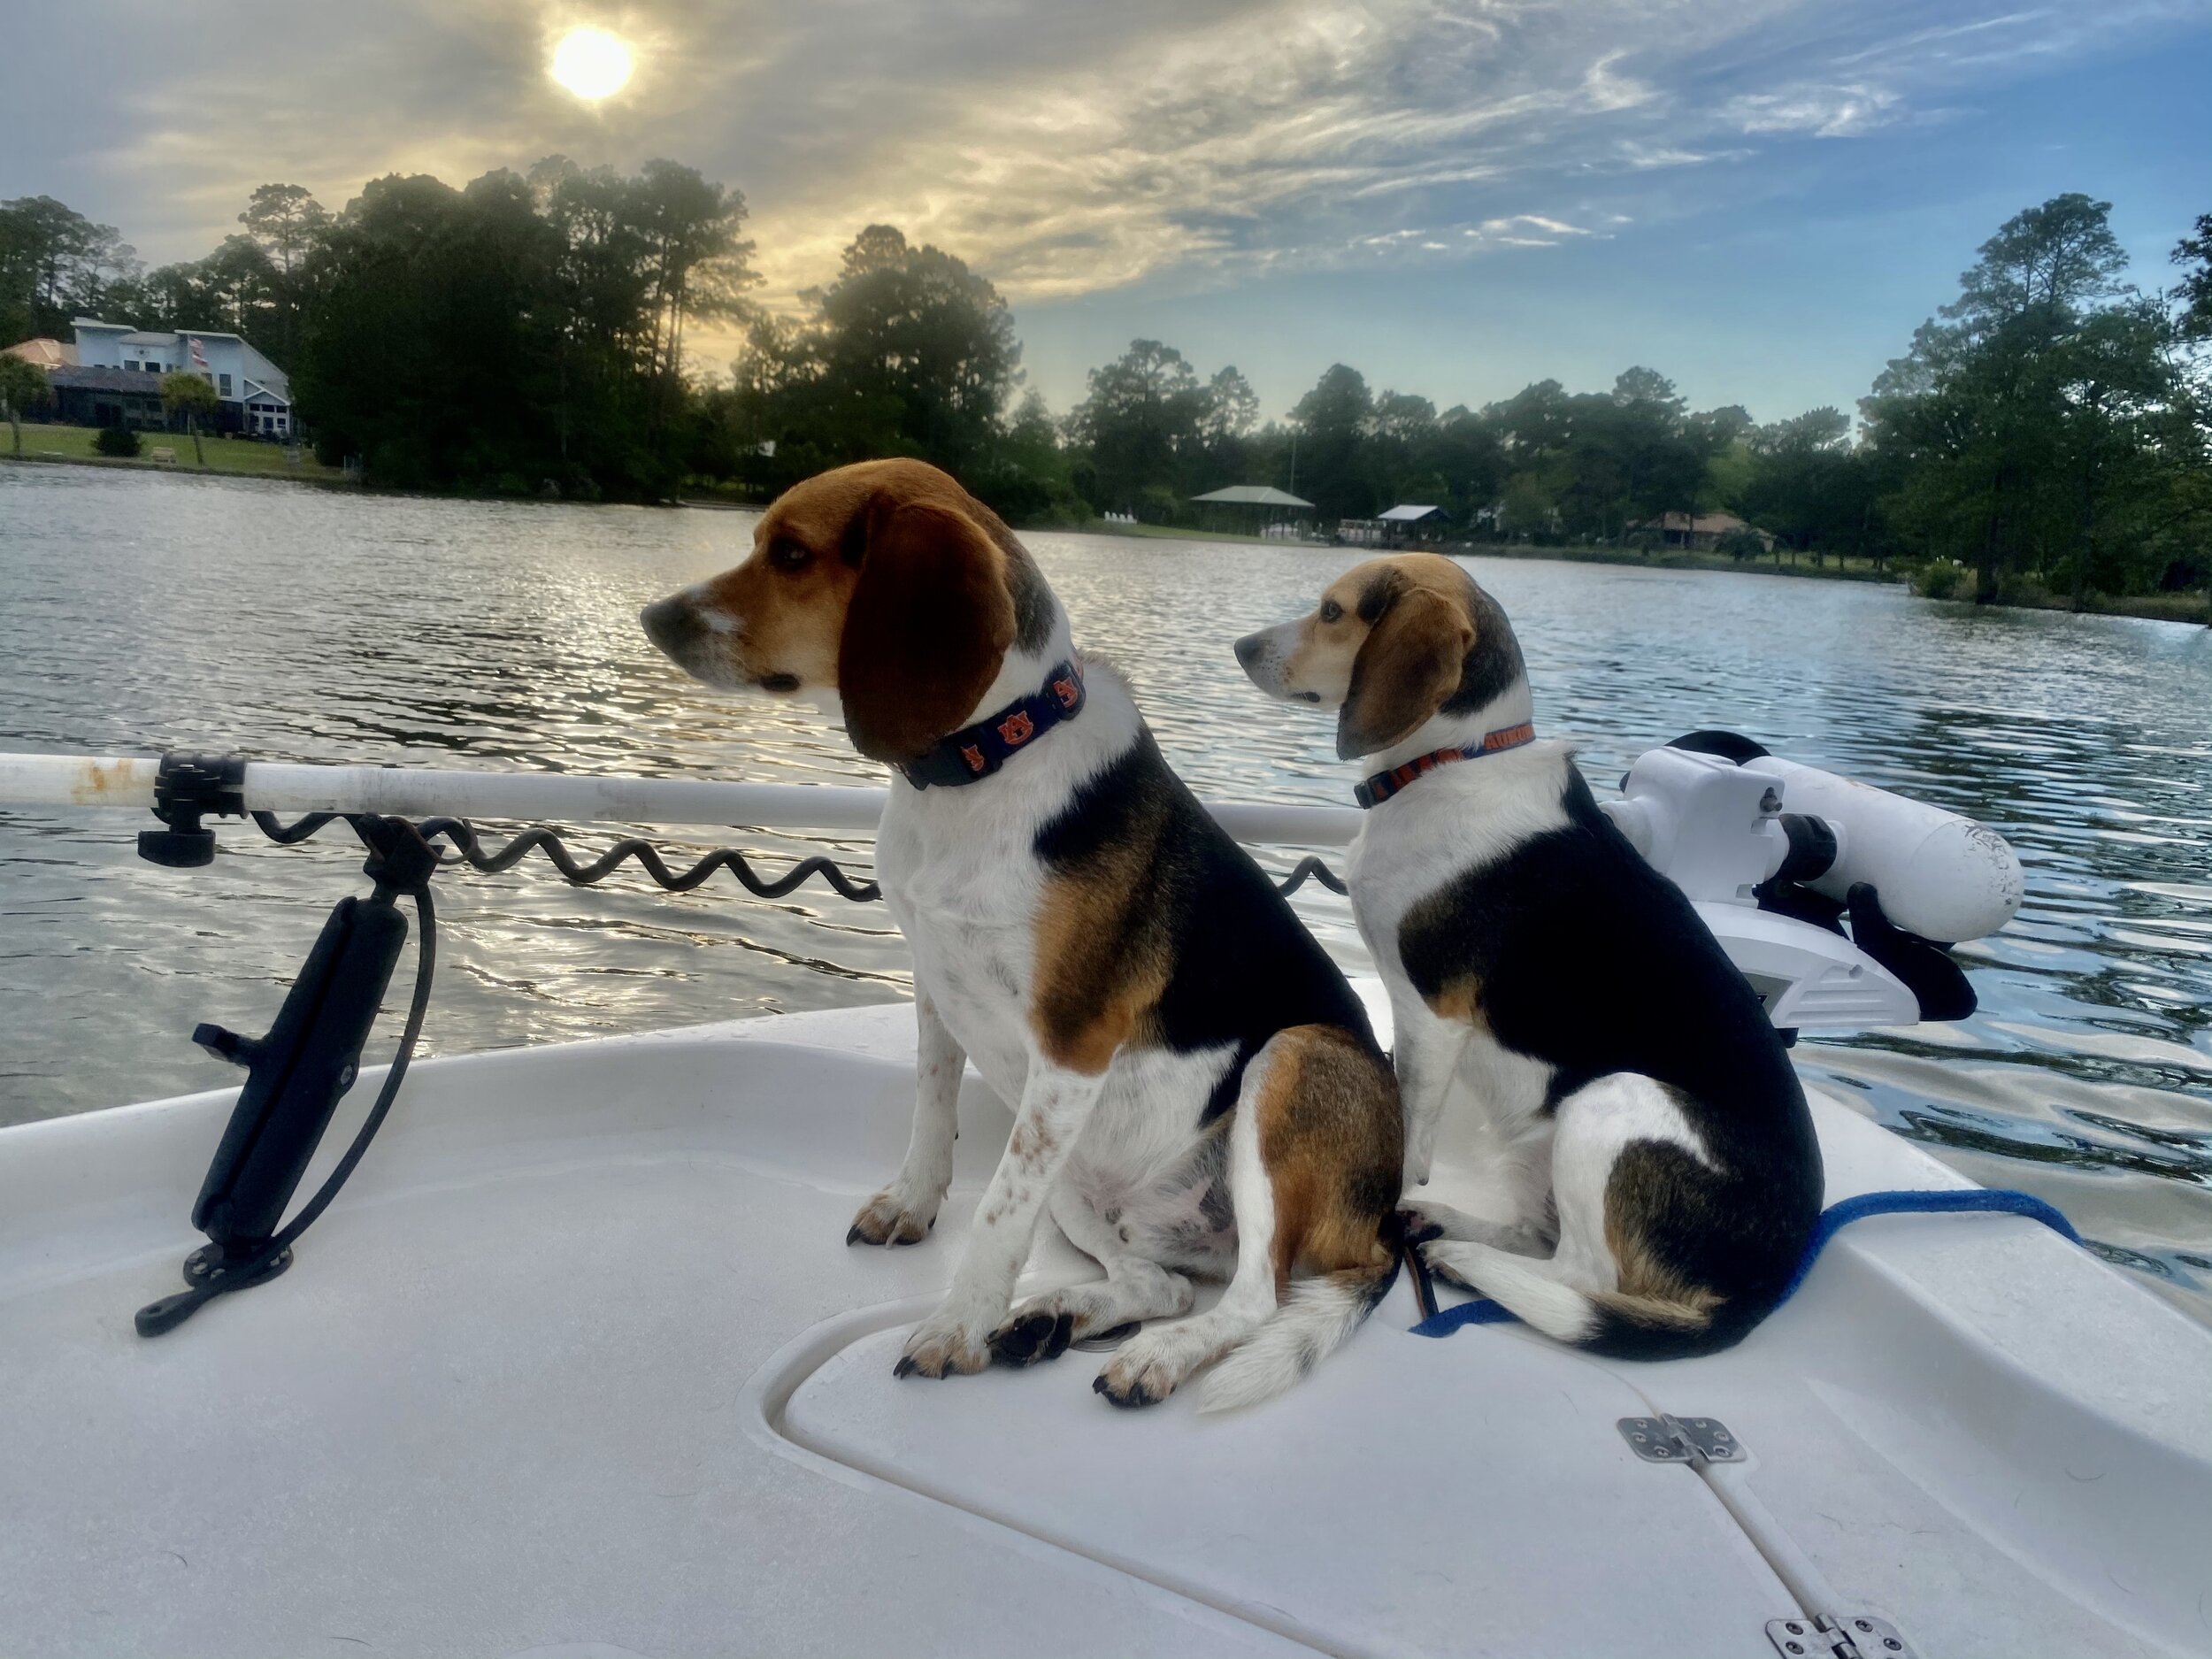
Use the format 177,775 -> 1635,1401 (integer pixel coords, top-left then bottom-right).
0,177 -> 2212,600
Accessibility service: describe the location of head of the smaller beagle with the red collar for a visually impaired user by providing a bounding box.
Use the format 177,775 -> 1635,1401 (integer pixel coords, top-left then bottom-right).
1237,553 -> 1526,761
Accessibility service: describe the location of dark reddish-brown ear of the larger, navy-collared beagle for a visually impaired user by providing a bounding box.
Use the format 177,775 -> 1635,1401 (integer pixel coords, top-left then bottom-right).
836,498 -> 1013,765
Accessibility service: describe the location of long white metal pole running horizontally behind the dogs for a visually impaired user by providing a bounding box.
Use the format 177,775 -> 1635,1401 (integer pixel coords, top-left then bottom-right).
0,755 -> 1361,848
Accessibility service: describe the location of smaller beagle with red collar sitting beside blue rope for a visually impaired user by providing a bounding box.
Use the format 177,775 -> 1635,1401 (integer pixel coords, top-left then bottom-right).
1237,553 -> 1821,1358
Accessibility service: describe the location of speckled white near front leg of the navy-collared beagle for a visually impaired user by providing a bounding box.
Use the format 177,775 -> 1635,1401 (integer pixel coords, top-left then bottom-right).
896,1056 -> 1106,1376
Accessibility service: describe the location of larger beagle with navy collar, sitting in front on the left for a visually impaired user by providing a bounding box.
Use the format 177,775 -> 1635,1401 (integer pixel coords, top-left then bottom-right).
641,460 -> 1405,1409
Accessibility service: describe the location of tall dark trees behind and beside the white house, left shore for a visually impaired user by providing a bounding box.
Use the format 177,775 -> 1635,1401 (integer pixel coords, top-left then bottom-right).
0,155 -> 759,500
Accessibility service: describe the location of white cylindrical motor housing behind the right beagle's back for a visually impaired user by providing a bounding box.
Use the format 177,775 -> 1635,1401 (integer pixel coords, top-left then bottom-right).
1741,755 -> 2024,945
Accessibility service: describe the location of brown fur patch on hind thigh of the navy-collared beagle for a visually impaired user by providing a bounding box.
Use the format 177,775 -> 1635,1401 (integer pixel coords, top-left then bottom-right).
1252,1026 -> 1405,1294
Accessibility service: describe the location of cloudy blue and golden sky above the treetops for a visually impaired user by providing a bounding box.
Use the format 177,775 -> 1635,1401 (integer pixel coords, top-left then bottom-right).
0,0 -> 2212,420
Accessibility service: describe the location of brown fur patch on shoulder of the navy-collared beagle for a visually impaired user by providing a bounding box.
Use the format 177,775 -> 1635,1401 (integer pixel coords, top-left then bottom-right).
1031,799 -> 1175,1075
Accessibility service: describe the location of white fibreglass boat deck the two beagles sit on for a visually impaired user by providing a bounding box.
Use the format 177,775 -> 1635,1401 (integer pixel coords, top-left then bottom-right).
0,1007 -> 2212,1659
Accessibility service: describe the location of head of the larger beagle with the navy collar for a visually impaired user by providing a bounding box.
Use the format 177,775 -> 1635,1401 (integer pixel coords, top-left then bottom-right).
640,460 -> 1042,764
